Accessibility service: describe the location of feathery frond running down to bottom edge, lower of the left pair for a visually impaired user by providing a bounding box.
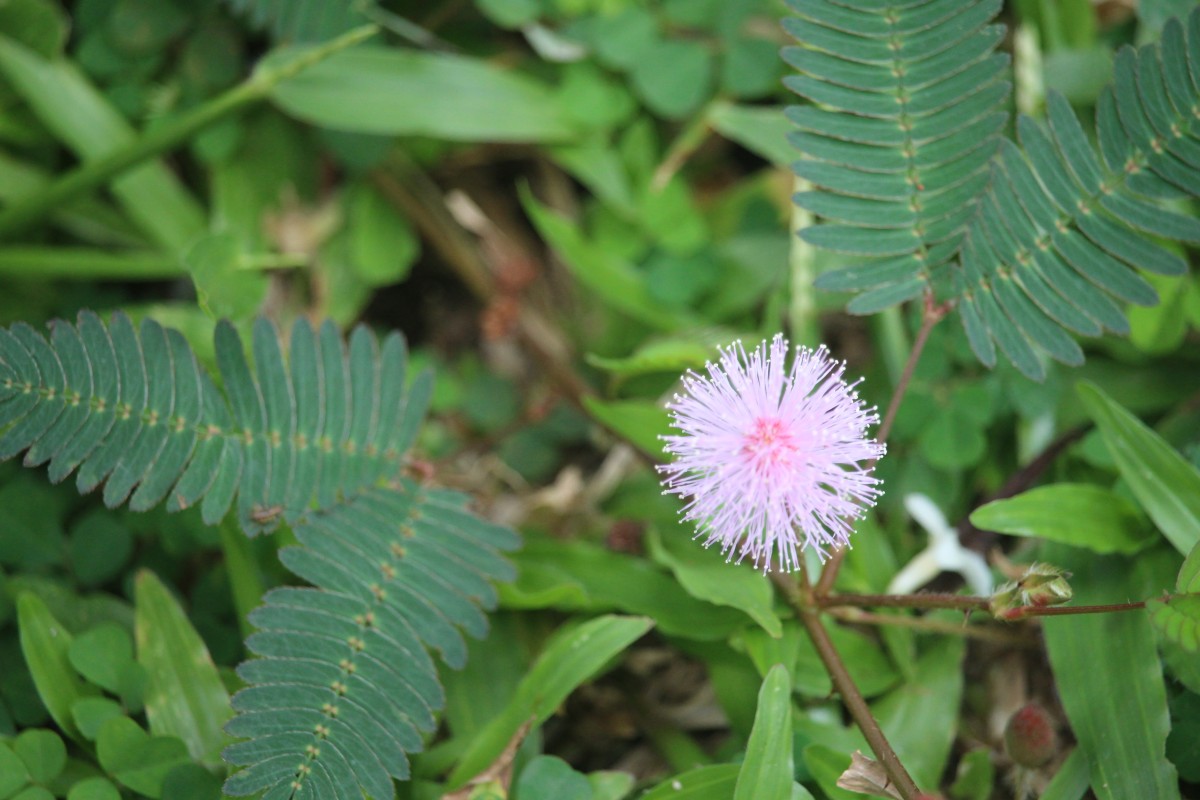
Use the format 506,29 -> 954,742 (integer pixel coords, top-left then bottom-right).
224,481 -> 517,800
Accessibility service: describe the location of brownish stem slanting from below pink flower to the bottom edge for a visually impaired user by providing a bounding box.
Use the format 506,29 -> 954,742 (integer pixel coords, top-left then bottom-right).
772,567 -> 920,800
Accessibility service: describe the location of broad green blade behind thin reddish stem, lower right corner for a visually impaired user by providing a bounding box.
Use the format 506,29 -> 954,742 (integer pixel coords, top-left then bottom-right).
1042,545 -> 1180,800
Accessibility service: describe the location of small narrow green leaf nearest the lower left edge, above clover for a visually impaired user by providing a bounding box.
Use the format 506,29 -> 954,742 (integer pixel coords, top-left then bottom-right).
17,593 -> 96,740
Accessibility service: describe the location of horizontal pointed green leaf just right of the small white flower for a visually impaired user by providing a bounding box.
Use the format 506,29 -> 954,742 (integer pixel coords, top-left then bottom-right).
971,483 -> 1156,554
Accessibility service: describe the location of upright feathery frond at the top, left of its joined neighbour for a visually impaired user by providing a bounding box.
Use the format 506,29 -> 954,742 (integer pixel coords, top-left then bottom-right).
784,0 -> 1009,313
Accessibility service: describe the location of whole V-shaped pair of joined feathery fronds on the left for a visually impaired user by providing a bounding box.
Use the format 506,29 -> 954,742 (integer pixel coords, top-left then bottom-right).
0,312 -> 517,800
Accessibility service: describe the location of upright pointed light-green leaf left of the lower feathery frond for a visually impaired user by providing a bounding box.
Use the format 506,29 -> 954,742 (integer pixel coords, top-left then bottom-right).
134,570 -> 233,765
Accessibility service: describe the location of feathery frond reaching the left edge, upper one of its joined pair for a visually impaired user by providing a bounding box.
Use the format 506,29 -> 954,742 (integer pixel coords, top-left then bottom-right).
0,312 -> 432,535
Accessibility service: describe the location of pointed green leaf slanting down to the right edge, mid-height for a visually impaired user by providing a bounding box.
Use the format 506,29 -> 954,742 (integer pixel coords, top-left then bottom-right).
1078,384 -> 1200,555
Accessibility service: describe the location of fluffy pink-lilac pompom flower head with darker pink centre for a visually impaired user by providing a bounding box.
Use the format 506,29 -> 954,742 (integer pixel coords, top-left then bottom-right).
659,335 -> 884,572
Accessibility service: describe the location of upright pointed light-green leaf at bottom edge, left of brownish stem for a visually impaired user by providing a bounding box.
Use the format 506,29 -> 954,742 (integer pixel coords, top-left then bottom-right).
733,664 -> 794,800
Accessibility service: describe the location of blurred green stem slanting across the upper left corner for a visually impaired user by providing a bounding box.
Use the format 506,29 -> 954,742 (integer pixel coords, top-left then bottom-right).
0,25 -> 378,237
